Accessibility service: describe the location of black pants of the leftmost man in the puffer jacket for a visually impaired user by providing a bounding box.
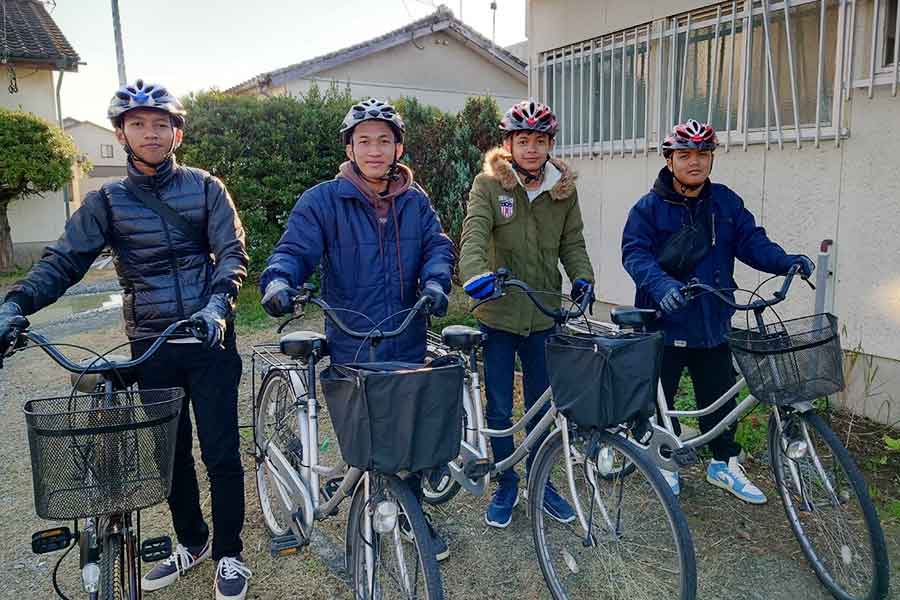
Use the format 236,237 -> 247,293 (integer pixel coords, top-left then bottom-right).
132,329 -> 244,560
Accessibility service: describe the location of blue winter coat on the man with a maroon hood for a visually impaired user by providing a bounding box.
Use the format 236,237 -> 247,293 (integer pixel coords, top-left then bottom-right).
260,177 -> 454,363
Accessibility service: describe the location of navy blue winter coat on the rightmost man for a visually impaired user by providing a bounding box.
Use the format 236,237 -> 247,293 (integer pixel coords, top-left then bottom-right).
622,167 -> 797,348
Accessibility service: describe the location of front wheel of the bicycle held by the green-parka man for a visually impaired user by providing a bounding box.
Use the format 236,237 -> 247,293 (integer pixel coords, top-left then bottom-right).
528,430 -> 697,600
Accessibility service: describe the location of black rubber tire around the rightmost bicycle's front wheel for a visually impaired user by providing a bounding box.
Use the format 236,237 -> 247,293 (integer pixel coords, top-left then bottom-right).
769,412 -> 890,600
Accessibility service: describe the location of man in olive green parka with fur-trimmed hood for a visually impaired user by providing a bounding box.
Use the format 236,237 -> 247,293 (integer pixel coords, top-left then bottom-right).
459,100 -> 594,528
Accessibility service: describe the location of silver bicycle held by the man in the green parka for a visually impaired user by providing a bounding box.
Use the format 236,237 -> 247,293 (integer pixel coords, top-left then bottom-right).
423,269 -> 697,600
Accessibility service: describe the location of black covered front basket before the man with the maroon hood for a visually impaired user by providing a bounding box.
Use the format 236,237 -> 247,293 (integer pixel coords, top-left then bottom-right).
321,357 -> 465,474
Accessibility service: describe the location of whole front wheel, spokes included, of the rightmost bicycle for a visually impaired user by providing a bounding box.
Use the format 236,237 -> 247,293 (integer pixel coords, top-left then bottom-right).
769,410 -> 889,600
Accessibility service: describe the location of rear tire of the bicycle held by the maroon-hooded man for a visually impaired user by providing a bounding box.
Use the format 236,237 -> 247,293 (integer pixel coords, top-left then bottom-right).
253,369 -> 304,536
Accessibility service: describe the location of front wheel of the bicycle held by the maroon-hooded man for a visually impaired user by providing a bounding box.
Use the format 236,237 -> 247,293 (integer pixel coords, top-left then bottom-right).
347,473 -> 444,600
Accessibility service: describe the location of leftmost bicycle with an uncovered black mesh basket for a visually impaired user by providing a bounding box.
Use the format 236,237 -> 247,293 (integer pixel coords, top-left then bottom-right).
0,319 -> 195,600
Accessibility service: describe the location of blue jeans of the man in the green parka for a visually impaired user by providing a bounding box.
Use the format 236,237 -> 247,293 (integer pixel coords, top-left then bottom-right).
480,323 -> 553,485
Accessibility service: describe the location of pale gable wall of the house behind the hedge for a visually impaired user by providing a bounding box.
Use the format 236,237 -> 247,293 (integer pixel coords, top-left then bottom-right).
287,33 -> 528,112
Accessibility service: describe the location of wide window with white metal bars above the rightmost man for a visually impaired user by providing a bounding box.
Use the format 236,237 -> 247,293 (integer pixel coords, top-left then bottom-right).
532,0 -> 856,156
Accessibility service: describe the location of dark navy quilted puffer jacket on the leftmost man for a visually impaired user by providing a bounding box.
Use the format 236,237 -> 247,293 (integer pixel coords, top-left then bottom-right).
6,158 -> 248,339
